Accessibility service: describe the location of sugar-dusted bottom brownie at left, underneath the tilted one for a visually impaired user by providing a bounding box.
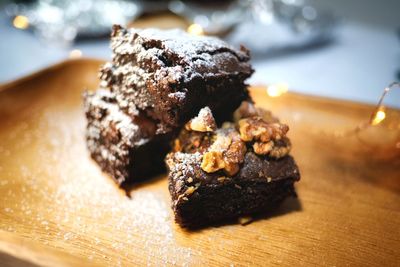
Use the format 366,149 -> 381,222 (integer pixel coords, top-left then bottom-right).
84,89 -> 173,185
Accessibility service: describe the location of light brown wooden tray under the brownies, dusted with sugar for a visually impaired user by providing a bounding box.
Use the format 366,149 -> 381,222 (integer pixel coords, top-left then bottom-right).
0,60 -> 400,266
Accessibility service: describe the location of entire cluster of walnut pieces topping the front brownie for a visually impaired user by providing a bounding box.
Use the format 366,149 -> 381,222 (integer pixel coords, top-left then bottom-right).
174,102 -> 290,182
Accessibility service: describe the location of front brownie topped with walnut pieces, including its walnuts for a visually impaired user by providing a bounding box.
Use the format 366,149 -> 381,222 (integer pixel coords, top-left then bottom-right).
166,103 -> 300,228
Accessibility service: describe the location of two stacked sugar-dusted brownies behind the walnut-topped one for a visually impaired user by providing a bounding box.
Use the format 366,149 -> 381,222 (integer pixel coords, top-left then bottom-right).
85,26 -> 253,185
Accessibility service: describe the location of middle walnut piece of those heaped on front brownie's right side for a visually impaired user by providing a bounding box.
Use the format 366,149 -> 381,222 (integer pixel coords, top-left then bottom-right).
239,117 -> 289,142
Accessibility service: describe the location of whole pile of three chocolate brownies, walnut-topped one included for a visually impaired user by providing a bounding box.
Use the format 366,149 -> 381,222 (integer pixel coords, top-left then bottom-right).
84,26 -> 300,227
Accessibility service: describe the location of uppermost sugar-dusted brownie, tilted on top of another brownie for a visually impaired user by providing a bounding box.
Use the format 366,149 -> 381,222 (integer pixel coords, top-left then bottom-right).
100,26 -> 253,133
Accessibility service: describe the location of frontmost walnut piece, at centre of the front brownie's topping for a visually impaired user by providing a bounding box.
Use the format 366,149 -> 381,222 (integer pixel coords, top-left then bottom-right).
201,129 -> 246,176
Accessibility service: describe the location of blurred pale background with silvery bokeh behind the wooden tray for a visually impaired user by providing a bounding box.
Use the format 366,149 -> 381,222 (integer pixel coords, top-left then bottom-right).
0,0 -> 400,107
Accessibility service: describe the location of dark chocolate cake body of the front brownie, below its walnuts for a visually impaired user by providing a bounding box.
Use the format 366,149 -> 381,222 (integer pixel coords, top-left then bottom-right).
167,152 -> 300,228
